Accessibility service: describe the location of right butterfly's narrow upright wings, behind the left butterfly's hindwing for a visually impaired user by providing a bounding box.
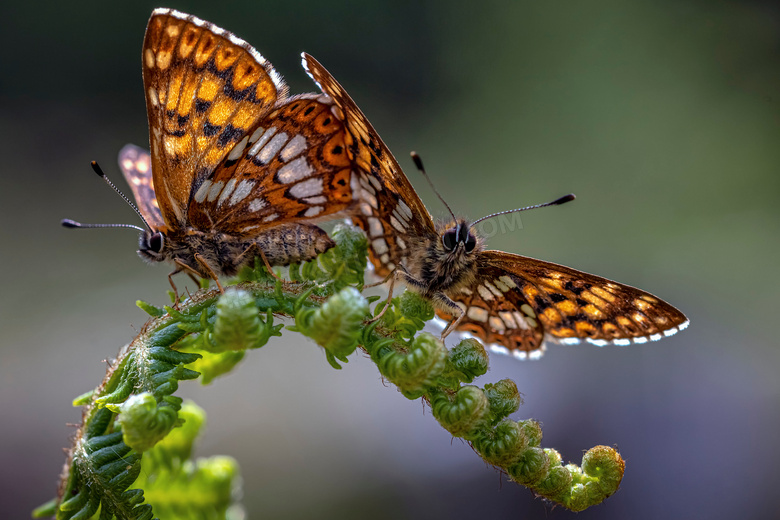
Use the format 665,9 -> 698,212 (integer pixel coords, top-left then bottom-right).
302,53 -> 436,276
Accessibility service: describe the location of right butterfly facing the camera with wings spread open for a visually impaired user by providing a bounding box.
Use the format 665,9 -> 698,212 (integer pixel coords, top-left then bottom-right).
303,54 -> 688,358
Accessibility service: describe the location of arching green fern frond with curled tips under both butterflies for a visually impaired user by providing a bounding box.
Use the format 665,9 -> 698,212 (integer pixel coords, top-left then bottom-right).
34,225 -> 624,520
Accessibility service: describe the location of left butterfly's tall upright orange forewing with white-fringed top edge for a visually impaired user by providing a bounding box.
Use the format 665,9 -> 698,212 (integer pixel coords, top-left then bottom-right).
143,9 -> 287,227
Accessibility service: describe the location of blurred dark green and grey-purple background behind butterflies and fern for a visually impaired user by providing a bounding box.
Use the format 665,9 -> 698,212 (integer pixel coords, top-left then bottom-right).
0,0 -> 780,519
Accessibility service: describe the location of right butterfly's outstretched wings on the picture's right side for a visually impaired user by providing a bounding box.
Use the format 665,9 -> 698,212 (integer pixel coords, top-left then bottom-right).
442,251 -> 689,357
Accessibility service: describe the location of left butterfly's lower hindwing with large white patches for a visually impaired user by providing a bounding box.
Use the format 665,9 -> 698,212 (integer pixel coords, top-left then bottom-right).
188,95 -> 353,235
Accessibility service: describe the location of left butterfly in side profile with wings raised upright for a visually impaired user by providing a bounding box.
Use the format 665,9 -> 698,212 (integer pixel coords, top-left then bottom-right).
63,9 -> 355,283
